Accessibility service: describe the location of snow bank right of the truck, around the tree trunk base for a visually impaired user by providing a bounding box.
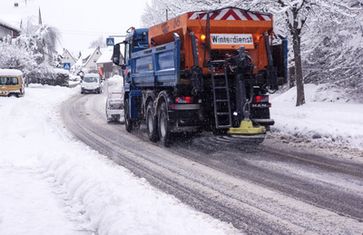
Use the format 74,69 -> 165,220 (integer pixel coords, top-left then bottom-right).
271,84 -> 363,149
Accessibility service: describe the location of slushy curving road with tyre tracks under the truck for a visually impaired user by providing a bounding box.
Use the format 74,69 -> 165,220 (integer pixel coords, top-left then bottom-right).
62,78 -> 363,235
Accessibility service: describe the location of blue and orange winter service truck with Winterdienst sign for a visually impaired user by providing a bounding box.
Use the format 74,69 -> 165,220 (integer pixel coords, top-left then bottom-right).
113,7 -> 287,146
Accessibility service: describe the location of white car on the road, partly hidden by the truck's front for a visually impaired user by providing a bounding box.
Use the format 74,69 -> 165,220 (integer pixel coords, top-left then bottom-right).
106,91 -> 125,123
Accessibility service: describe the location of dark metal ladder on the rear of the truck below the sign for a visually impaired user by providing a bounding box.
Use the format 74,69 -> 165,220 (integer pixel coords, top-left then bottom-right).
210,63 -> 232,129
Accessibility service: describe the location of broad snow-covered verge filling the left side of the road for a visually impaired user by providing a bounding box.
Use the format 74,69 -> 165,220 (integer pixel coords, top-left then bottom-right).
0,86 -> 237,235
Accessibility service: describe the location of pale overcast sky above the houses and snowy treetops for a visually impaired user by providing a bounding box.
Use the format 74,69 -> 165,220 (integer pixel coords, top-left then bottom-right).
0,0 -> 148,52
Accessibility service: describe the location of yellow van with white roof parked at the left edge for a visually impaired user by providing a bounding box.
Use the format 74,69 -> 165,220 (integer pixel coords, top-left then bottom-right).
0,69 -> 25,97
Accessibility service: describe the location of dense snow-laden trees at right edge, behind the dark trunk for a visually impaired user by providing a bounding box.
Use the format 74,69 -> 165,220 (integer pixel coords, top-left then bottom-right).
302,0 -> 363,98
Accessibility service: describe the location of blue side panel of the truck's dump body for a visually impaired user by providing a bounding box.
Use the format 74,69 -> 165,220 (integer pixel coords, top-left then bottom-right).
130,32 -> 180,88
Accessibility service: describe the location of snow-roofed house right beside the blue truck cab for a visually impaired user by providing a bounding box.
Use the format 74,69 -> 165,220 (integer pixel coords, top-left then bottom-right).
97,48 -> 119,79
